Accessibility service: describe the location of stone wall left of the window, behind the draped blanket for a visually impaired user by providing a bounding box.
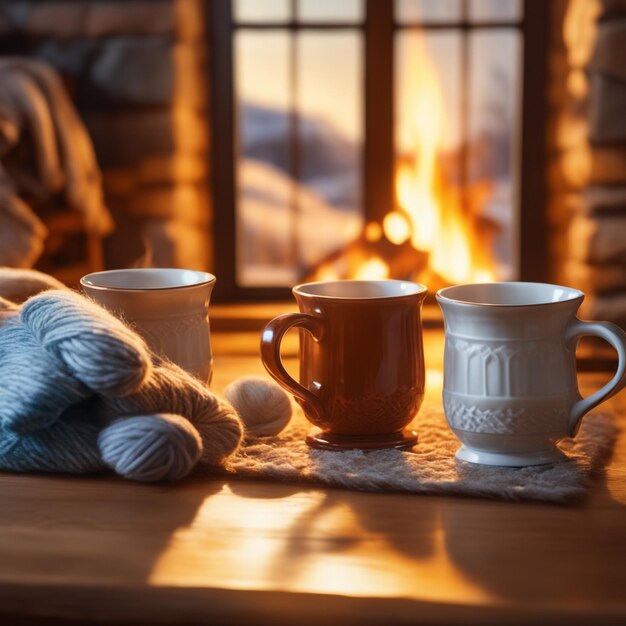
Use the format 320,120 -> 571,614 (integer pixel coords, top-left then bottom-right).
0,0 -> 212,269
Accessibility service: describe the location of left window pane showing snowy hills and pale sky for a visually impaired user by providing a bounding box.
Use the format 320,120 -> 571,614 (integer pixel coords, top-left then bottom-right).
235,30 -> 362,286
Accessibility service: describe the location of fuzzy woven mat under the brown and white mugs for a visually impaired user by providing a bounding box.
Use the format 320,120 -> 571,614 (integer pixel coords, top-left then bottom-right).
226,404 -> 618,503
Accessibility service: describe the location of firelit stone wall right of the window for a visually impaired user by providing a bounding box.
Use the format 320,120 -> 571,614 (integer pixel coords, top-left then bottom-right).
549,0 -> 626,327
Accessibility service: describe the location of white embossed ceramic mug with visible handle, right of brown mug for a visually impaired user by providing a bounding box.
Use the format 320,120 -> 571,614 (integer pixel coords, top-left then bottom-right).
437,282 -> 626,466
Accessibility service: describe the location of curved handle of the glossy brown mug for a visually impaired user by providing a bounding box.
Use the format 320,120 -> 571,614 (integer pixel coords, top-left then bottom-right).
261,313 -> 324,419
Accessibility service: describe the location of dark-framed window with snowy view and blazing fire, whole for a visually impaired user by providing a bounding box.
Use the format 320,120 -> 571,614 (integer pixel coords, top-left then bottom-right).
209,0 -> 549,299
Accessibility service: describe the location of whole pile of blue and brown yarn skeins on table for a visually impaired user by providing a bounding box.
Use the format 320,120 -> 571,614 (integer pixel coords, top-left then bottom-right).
0,286 -> 242,481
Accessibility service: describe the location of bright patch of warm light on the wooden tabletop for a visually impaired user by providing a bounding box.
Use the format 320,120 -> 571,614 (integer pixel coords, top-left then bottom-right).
149,486 -> 494,602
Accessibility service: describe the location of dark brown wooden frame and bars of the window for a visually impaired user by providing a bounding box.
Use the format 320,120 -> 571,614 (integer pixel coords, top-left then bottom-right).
206,0 -> 549,302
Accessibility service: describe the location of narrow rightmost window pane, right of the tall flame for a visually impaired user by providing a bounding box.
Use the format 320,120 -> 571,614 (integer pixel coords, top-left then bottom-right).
468,29 -> 521,279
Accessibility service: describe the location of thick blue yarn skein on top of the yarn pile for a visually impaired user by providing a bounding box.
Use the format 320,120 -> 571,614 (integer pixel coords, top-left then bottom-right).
0,291 -> 151,434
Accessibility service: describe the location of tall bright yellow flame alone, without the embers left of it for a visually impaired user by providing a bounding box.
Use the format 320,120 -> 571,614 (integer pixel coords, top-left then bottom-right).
392,39 -> 495,282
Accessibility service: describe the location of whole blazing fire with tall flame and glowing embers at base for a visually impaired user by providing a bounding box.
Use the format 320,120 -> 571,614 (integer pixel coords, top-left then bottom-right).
309,39 -> 497,288
